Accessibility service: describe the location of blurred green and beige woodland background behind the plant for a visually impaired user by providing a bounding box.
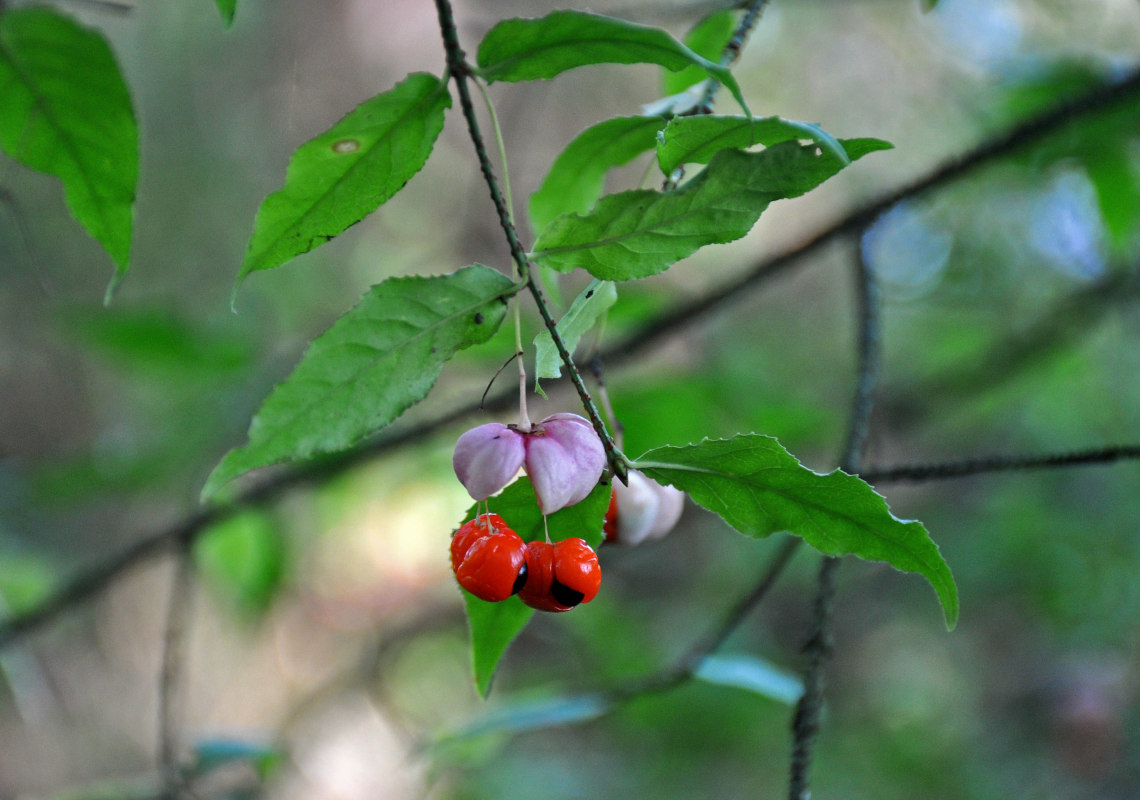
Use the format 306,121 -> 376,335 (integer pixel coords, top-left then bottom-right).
0,0 -> 1140,800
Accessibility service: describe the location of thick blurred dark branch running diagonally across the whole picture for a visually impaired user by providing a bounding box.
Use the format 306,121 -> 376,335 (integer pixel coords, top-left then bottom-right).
0,59 -> 1140,648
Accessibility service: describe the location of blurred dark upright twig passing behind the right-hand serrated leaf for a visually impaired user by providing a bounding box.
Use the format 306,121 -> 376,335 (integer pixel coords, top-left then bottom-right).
788,240 -> 882,800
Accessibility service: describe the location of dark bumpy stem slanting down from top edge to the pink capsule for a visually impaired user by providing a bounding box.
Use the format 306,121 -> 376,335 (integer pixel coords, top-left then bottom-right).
435,0 -> 628,483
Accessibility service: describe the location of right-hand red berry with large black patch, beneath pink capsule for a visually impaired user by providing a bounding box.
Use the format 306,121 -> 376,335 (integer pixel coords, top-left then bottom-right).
519,539 -> 602,611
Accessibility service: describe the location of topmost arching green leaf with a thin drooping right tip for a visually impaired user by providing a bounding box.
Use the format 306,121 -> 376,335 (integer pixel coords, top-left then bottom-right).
477,11 -> 748,112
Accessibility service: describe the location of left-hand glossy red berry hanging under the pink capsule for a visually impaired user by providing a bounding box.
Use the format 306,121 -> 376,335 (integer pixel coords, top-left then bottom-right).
451,514 -> 527,603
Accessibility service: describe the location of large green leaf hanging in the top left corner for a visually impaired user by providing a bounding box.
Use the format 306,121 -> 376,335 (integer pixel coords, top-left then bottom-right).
0,7 -> 139,301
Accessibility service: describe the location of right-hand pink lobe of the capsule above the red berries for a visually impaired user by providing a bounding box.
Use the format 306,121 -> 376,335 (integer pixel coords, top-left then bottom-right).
526,414 -> 605,514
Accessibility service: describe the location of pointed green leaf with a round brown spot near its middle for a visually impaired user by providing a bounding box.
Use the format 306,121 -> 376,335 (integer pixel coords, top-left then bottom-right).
238,73 -> 451,288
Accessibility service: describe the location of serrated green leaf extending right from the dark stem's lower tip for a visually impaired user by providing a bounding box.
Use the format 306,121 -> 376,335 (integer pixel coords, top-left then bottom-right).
634,433 -> 958,628
